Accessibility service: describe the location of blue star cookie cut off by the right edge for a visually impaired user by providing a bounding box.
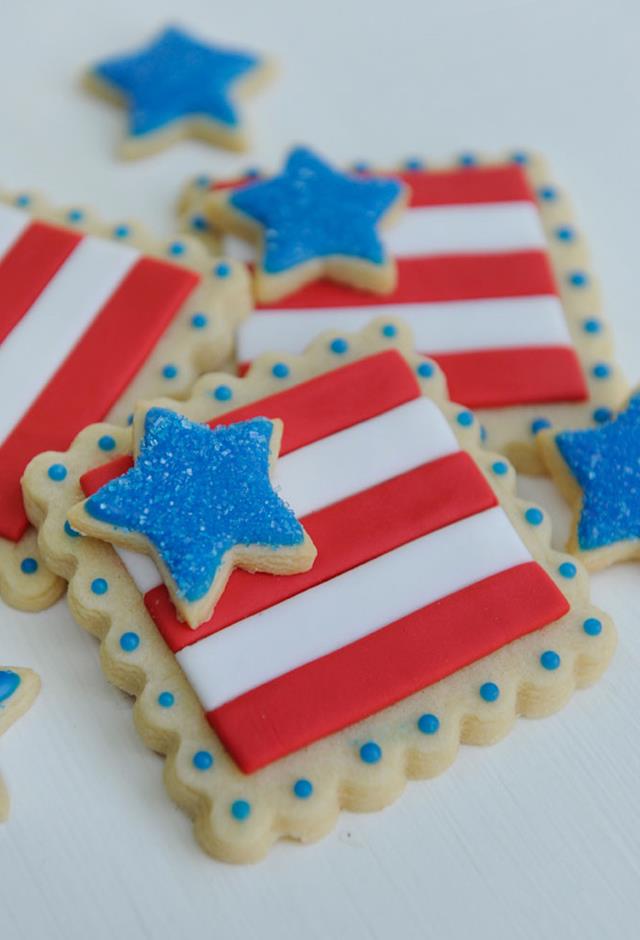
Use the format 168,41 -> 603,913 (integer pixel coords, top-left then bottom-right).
538,391 -> 640,570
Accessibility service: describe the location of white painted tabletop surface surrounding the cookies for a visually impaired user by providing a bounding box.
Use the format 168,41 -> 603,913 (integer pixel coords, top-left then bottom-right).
0,0 -> 640,940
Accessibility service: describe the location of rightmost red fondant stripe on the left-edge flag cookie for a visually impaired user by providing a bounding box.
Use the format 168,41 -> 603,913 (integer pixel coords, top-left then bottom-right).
0,258 -> 200,541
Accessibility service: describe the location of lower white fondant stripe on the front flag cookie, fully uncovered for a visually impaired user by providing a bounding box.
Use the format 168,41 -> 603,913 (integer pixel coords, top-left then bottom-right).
177,508 -> 531,711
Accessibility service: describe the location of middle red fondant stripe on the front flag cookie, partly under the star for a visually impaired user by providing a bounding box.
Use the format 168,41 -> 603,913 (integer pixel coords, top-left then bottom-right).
145,451 -> 497,653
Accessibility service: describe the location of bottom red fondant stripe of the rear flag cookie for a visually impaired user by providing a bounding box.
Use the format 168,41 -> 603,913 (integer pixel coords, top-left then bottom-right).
432,346 -> 588,408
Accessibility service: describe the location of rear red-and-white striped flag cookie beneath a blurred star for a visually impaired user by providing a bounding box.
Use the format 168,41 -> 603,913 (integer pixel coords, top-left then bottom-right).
181,154 -> 626,472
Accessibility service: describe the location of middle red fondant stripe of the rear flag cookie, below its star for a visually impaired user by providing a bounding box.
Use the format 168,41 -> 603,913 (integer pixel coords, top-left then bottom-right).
255,251 -> 558,316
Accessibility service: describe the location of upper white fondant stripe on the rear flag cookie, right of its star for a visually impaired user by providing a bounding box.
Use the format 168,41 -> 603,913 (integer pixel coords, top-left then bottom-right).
384,202 -> 545,257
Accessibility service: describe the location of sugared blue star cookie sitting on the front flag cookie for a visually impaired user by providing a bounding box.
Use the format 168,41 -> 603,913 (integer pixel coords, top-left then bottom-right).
69,408 -> 316,628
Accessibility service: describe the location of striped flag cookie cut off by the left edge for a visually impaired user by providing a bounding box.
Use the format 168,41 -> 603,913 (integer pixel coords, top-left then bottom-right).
0,194 -> 250,609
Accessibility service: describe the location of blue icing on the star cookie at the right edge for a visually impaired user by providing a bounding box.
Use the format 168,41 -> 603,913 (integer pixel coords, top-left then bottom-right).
556,395 -> 640,550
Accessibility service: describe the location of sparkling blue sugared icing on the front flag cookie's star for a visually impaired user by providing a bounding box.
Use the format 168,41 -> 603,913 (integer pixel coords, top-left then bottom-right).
85,408 -> 304,602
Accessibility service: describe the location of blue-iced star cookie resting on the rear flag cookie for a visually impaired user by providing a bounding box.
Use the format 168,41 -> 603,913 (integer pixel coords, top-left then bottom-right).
206,147 -> 406,303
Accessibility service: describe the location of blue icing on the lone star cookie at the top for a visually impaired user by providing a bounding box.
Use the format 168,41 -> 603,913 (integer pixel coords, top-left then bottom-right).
93,26 -> 261,136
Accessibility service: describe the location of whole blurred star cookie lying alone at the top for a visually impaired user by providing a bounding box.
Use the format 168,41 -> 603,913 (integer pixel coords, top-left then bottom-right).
87,26 -> 271,157
